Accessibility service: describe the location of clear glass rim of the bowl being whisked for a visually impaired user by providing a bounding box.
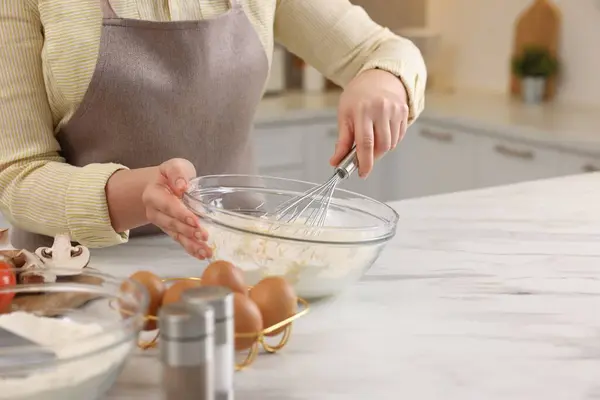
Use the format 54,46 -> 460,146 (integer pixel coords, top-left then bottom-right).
183,174 -> 400,245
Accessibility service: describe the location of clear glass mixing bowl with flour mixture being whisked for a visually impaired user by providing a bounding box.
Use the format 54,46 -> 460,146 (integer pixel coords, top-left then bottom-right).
183,175 -> 398,299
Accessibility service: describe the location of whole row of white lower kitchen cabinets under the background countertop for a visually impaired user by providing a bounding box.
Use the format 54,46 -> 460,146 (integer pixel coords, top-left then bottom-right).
254,115 -> 600,205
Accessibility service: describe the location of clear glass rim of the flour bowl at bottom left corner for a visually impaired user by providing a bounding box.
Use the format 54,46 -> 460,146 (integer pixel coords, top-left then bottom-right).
0,268 -> 150,376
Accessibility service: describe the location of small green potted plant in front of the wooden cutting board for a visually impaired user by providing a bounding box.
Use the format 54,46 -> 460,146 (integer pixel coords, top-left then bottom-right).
512,46 -> 558,104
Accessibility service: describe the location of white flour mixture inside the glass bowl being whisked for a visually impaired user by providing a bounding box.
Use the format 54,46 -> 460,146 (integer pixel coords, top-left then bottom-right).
204,209 -> 382,297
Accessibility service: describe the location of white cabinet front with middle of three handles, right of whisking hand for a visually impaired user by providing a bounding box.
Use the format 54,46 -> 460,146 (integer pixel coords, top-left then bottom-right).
475,137 -> 562,187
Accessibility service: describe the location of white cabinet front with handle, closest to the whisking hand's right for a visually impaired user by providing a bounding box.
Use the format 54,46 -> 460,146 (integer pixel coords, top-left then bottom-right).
390,122 -> 479,199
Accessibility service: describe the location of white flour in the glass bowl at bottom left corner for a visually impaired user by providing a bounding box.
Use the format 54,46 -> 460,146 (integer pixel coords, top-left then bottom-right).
0,312 -> 134,400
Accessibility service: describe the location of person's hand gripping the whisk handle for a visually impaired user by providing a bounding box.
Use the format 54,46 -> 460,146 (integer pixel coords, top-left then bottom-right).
330,69 -> 408,178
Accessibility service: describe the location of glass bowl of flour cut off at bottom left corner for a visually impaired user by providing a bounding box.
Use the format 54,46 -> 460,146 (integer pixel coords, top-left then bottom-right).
0,269 -> 148,400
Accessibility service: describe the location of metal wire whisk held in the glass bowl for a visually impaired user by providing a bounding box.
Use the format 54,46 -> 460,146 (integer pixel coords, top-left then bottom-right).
272,145 -> 358,227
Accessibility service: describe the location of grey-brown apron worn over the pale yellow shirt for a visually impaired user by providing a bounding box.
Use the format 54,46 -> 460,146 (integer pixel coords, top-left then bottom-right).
11,0 -> 268,250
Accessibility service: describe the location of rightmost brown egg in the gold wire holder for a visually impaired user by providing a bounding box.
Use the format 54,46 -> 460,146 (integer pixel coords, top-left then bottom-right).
250,276 -> 298,336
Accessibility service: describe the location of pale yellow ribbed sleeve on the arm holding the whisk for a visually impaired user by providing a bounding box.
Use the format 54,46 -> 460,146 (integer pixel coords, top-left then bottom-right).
274,0 -> 427,123
